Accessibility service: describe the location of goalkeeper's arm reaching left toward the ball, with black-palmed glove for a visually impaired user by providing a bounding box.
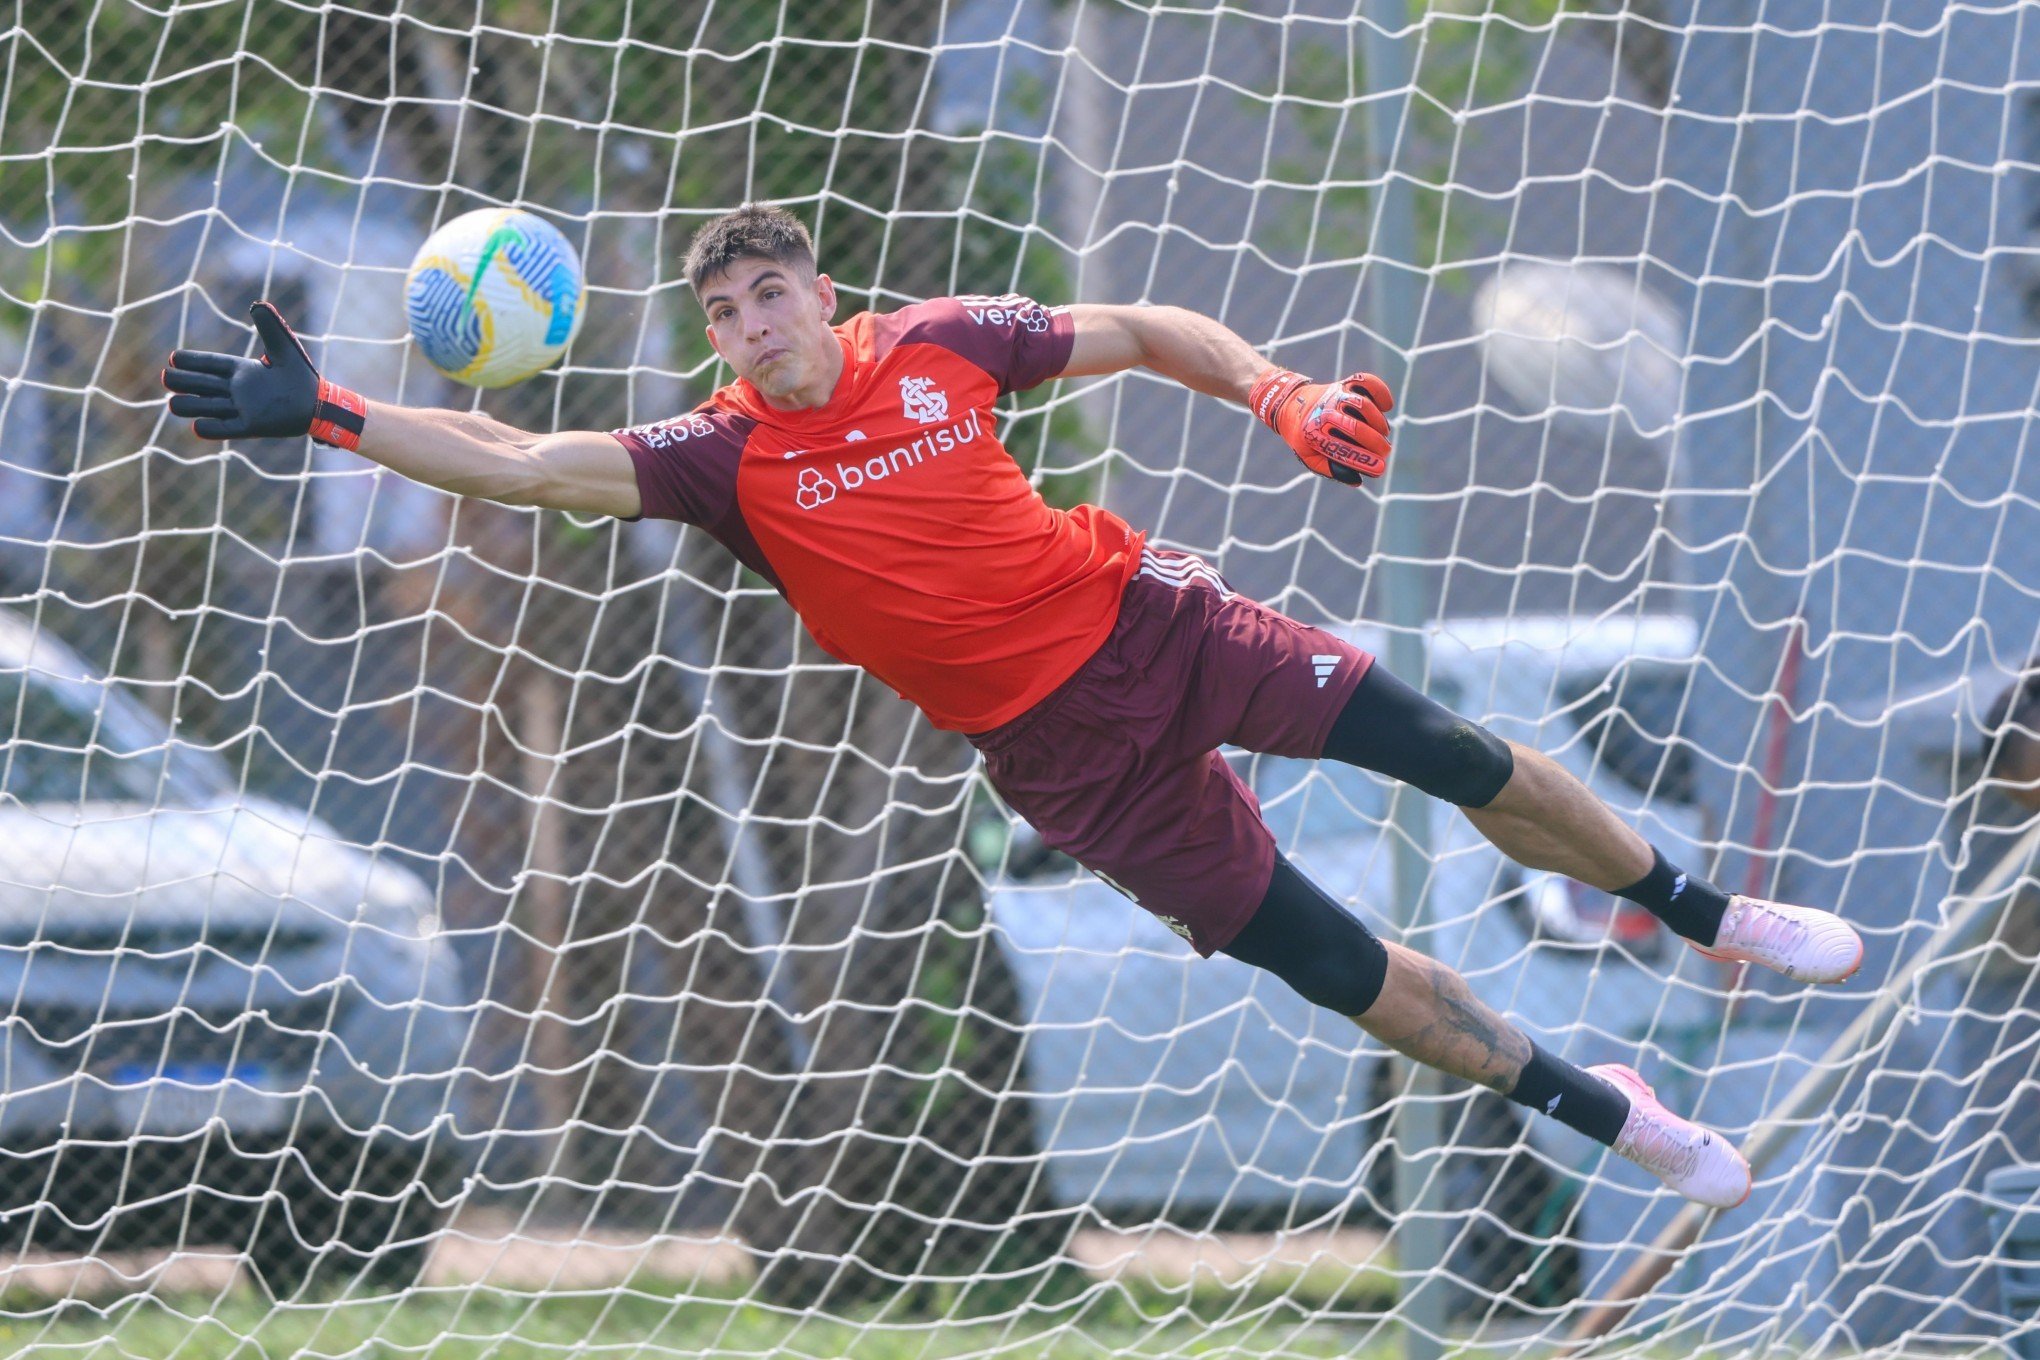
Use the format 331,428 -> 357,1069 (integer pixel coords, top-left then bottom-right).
163,302 -> 641,518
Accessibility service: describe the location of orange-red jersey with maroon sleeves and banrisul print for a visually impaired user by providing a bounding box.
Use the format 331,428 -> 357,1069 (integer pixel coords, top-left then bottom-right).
614,296 -> 1140,732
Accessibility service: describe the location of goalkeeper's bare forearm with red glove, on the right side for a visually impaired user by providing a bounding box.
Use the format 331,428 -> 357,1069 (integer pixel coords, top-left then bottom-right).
1063,304 -> 1395,485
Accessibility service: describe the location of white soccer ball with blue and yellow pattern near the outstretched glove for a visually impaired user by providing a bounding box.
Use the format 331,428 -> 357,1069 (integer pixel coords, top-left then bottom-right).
404,208 -> 585,387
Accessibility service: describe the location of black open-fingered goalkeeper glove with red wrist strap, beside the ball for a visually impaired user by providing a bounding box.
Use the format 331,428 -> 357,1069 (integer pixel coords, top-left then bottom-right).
163,302 -> 367,449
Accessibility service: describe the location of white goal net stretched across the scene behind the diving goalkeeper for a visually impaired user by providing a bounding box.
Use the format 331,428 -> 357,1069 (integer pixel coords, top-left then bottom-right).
0,0 -> 2040,1356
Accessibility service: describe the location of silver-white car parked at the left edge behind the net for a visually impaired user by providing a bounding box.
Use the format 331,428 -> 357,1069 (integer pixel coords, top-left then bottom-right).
0,610 -> 471,1293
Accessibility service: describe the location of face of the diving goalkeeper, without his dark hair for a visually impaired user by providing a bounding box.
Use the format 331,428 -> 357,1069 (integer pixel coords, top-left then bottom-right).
702,257 -> 843,402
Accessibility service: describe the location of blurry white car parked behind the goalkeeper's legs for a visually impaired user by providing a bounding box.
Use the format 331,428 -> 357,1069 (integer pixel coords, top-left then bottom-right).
987,616 -> 1718,1304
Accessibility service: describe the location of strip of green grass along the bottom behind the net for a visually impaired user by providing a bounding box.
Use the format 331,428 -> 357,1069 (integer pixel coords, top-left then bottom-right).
0,1272 -> 1399,1360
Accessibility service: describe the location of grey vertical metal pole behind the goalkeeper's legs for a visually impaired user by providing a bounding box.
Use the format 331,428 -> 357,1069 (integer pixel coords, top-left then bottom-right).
1361,0 -> 1450,1360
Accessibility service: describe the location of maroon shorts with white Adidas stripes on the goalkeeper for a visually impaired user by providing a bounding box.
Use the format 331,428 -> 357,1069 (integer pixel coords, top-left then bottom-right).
971,548 -> 1373,956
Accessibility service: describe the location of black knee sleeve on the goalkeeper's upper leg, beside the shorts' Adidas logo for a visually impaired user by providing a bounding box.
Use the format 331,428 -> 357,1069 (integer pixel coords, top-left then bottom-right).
1324,661 -> 1516,807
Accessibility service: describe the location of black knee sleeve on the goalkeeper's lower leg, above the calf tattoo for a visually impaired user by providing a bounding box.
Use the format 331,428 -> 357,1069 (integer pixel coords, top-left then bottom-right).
1220,854 -> 1389,1015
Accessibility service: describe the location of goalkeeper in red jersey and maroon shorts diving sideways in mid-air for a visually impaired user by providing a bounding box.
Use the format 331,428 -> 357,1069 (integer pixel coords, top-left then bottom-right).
163,206 -> 1863,1207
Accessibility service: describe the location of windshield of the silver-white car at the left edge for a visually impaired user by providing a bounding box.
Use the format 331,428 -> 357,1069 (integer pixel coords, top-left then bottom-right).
0,671 -> 233,805
